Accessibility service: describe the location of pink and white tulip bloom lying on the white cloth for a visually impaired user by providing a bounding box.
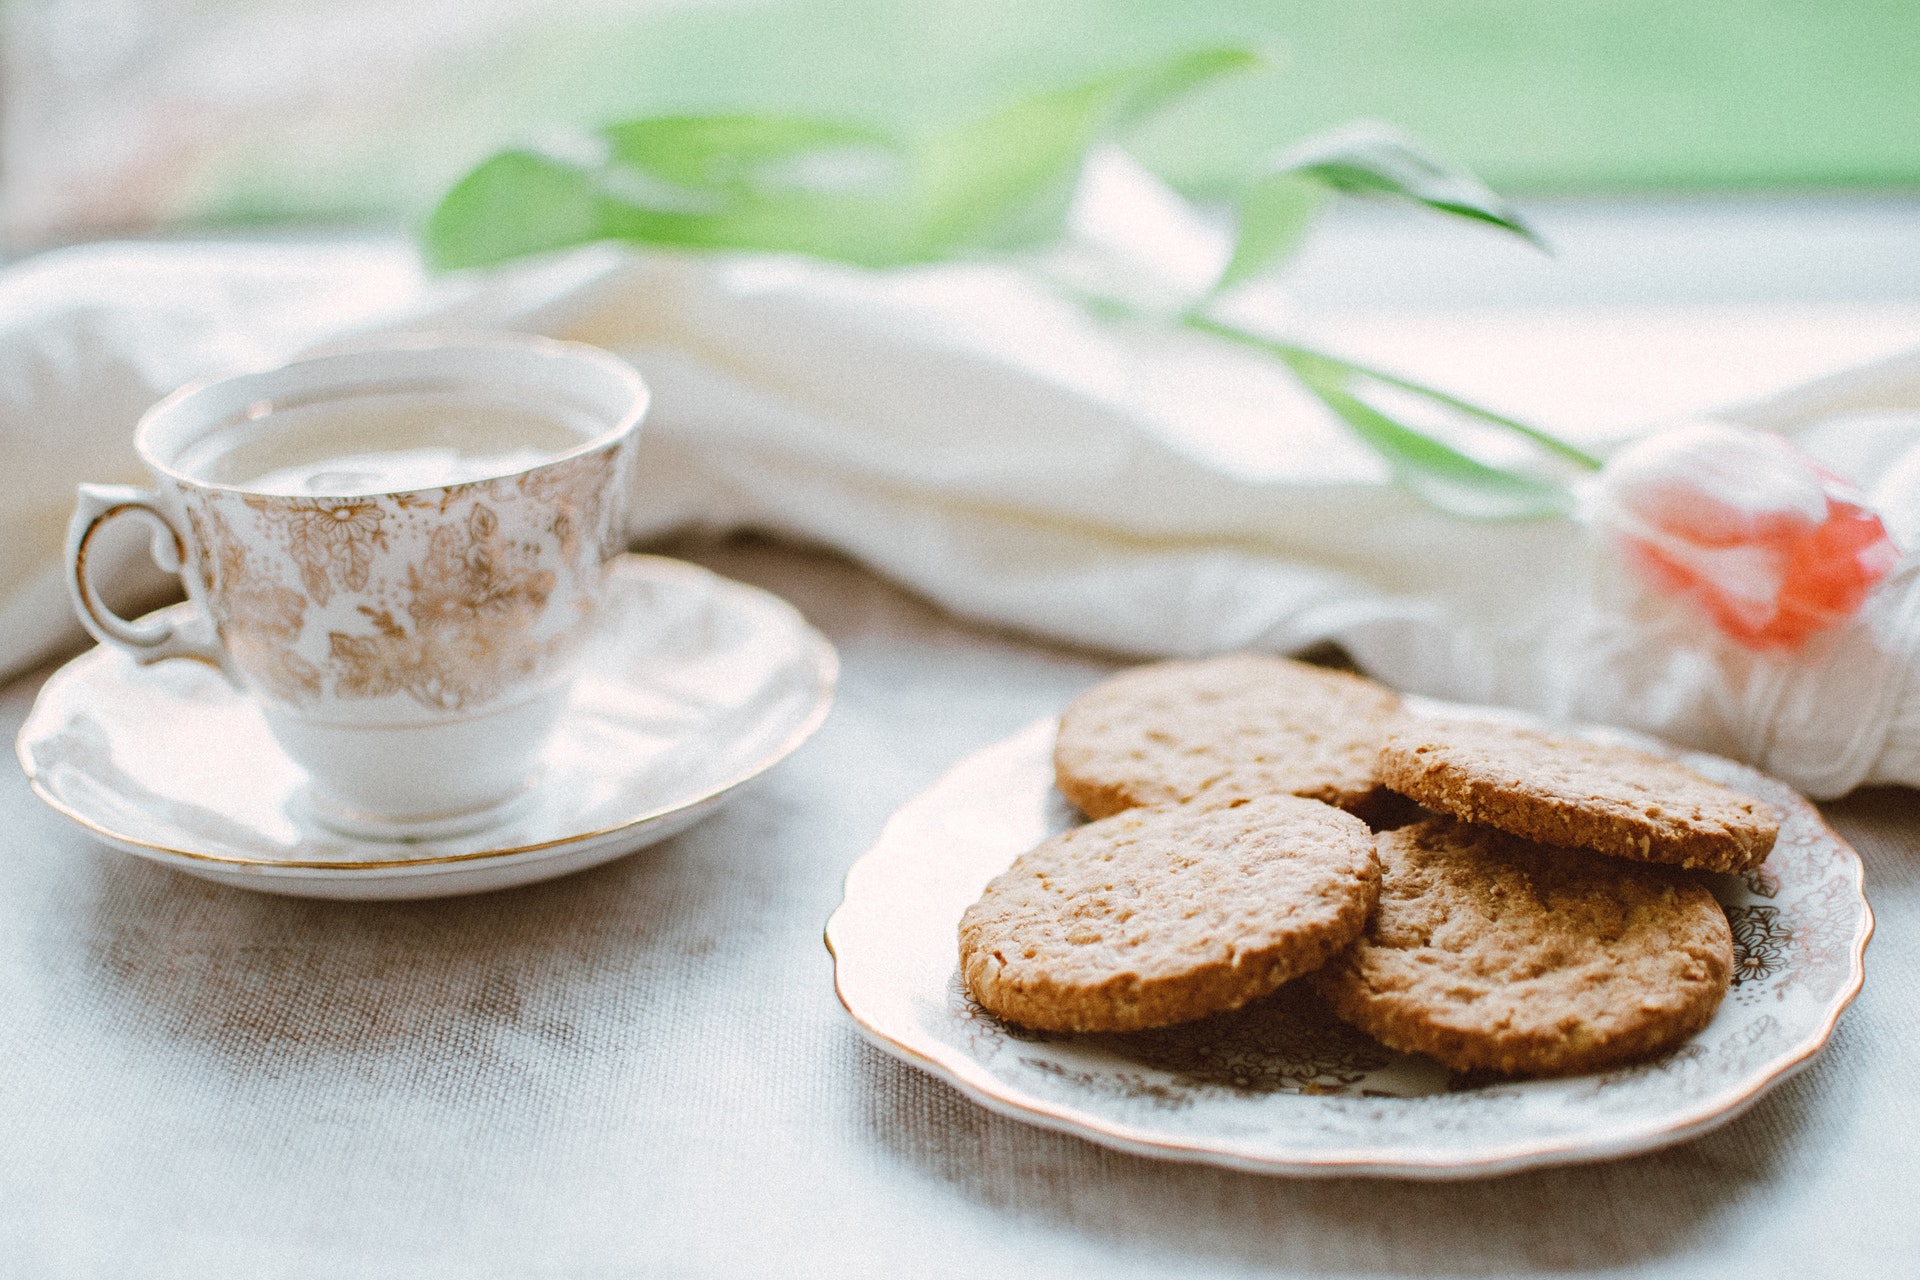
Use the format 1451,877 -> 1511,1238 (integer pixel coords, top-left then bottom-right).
1590,422 -> 1901,651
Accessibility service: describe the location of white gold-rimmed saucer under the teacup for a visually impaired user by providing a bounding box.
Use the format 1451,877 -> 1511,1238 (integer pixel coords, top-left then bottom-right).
17,555 -> 839,898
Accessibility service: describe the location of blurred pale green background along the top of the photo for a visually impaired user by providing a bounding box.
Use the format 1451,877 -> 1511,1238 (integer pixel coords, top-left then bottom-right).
6,0 -> 1920,242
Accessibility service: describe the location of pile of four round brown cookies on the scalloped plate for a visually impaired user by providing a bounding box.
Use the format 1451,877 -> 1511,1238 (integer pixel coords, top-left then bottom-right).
960,654 -> 1778,1075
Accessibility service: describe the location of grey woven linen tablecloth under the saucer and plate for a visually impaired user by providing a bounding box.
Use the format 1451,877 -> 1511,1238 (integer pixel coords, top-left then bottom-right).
0,547 -> 1920,1280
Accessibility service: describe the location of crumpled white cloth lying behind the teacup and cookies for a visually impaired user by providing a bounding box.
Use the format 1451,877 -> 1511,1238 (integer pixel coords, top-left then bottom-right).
11,246 -> 1920,796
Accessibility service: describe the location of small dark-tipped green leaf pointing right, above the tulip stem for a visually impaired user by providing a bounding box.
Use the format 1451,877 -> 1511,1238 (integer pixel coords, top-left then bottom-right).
1271,121 -> 1548,249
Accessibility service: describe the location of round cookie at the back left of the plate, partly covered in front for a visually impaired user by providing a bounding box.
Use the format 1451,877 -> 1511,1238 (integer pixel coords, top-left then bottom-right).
1054,652 -> 1400,818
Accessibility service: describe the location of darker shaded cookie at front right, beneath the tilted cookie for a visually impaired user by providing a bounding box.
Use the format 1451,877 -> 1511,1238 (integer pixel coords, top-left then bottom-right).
1313,818 -> 1734,1075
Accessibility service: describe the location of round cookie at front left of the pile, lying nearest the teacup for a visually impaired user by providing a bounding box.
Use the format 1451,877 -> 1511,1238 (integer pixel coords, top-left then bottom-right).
960,796 -> 1380,1031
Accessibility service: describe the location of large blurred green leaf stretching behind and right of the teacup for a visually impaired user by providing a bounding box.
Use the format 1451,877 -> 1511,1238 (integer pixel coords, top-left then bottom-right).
422,50 -> 1258,267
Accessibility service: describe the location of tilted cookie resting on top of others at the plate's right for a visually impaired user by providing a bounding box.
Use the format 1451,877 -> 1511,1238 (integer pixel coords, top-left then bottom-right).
1380,718 -> 1780,871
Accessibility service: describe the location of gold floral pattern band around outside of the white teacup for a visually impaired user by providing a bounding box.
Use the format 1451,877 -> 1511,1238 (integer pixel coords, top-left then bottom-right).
179,447 -> 622,712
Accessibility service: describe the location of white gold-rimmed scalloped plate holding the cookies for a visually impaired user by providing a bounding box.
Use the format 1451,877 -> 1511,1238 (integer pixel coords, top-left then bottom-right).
828,717 -> 1874,1178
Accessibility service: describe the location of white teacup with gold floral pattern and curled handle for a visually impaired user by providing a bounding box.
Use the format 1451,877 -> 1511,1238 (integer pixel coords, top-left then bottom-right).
67,336 -> 647,839
